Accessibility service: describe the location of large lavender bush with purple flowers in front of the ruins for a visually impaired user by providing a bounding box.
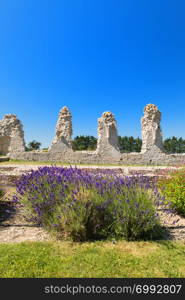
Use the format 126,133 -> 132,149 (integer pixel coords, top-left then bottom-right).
14,167 -> 161,241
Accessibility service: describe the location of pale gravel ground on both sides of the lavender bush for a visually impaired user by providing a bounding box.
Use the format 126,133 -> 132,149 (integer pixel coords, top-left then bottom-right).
0,197 -> 185,243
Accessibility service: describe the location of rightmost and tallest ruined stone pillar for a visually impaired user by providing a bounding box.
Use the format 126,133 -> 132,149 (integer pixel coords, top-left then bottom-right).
141,104 -> 163,153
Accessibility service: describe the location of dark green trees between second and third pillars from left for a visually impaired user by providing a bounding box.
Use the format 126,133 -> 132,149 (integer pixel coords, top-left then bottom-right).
72,135 -> 97,151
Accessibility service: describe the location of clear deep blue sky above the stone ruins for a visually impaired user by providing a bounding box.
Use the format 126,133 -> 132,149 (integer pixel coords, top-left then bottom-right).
0,0 -> 185,147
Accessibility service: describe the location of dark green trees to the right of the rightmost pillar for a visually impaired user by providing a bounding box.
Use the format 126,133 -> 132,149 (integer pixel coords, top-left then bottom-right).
164,136 -> 185,153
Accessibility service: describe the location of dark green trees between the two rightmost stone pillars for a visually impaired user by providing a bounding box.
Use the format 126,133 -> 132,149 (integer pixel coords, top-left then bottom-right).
118,136 -> 142,152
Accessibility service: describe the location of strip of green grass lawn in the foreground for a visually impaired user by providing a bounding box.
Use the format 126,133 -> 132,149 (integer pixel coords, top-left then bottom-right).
0,241 -> 185,278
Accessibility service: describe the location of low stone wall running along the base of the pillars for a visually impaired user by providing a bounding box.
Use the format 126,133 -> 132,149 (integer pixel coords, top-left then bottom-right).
10,151 -> 185,166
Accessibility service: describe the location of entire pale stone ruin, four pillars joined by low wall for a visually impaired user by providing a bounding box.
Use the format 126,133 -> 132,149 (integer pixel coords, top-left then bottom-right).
0,104 -> 185,165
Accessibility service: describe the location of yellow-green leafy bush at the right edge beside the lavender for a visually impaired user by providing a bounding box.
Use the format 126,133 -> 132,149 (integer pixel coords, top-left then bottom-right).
159,169 -> 185,216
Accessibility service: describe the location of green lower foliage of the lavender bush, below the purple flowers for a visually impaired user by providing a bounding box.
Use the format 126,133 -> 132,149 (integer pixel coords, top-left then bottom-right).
45,189 -> 160,241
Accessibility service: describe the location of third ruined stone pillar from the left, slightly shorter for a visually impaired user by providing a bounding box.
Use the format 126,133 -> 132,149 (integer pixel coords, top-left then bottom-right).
96,111 -> 120,157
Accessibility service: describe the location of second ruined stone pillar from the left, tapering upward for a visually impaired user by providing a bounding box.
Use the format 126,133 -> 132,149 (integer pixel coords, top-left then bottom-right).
51,106 -> 72,148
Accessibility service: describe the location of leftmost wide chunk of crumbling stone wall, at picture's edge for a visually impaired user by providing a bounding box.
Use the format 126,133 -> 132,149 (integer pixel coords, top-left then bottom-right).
0,114 -> 25,155
